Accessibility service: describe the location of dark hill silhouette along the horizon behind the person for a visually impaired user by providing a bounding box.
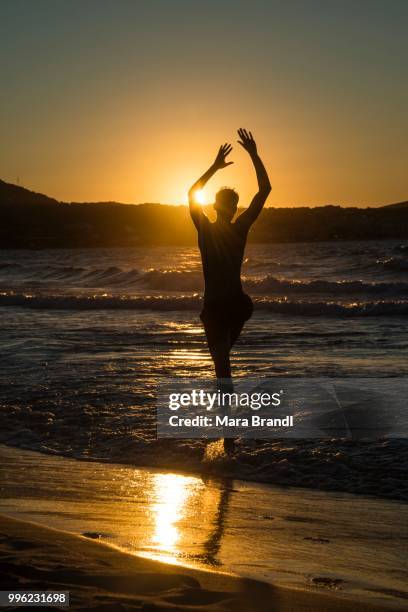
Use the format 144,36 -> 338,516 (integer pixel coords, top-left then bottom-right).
0,181 -> 408,248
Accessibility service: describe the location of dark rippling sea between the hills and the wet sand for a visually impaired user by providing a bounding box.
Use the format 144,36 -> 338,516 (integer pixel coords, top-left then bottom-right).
0,241 -> 408,500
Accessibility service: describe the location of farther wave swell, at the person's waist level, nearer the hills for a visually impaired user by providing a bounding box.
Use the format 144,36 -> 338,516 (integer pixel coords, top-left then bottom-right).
0,257 -> 408,297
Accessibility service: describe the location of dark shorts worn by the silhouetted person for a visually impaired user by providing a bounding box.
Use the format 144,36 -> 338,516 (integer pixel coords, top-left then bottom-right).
200,293 -> 254,335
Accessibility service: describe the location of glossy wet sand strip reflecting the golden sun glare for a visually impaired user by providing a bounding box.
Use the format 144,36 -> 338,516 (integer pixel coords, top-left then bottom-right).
0,446 -> 408,609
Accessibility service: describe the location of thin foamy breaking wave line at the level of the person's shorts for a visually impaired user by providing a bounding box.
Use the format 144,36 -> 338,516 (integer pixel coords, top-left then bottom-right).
0,292 -> 408,317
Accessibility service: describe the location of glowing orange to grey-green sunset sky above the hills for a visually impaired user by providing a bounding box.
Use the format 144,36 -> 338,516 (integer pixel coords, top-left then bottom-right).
0,0 -> 408,206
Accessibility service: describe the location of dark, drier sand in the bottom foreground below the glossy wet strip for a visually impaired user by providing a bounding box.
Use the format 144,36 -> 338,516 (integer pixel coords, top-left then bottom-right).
0,514 -> 395,612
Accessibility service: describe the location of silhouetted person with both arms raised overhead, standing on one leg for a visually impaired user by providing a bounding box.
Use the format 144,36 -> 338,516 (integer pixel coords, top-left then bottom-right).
188,129 -> 271,388
